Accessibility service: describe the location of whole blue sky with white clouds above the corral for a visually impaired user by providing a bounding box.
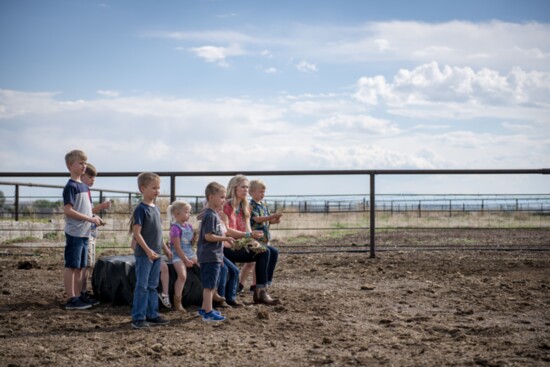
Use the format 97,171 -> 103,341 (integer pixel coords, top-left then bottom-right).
0,0 -> 550,194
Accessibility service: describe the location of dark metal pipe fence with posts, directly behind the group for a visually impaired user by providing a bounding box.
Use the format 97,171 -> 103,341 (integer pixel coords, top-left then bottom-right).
0,168 -> 550,257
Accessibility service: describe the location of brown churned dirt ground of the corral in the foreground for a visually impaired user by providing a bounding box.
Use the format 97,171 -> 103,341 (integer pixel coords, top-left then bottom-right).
0,232 -> 550,366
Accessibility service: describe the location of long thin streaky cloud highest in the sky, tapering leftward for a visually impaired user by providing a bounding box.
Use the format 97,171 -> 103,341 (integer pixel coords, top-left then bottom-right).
146,21 -> 550,73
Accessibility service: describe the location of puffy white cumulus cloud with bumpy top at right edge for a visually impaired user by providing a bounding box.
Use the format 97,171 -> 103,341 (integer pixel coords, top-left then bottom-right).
354,62 -> 550,120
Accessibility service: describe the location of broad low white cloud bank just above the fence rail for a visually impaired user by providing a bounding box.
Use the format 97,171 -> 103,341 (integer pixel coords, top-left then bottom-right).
0,89 -> 550,183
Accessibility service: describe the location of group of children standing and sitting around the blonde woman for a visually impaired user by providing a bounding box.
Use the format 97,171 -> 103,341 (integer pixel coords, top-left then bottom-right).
63,150 -> 281,329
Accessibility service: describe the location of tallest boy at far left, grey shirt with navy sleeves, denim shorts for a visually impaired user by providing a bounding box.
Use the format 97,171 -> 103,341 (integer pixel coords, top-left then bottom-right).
63,150 -> 101,310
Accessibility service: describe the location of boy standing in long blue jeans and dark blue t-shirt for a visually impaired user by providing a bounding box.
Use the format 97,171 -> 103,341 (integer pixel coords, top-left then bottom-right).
130,172 -> 168,329
